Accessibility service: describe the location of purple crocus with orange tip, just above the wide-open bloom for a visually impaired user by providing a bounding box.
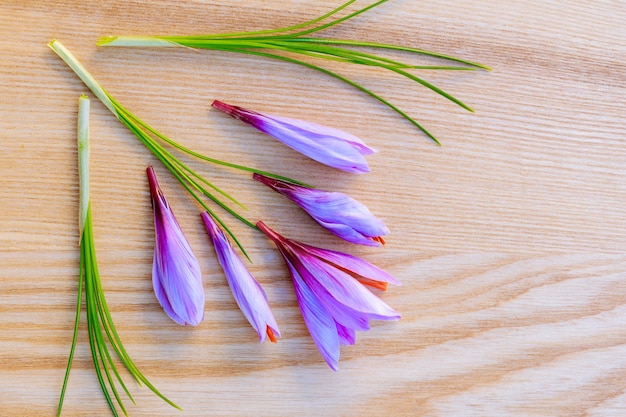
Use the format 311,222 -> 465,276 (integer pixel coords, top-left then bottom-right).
253,174 -> 389,246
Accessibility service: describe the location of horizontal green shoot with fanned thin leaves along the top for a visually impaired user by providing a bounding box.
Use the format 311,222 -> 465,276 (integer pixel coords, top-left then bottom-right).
97,0 -> 491,144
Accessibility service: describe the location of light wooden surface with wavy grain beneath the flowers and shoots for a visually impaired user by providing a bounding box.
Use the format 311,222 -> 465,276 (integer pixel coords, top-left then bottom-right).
0,0 -> 626,417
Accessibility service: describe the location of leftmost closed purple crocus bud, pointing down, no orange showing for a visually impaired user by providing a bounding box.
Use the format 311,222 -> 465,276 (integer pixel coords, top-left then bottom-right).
147,167 -> 204,326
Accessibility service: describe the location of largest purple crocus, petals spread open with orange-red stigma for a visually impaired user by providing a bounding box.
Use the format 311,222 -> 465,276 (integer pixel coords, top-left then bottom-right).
257,222 -> 400,371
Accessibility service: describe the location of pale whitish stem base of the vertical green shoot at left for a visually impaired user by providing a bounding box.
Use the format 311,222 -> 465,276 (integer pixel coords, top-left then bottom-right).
78,94 -> 89,239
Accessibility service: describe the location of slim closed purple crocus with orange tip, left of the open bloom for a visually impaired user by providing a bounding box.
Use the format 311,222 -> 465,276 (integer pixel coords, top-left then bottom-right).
202,212 -> 280,343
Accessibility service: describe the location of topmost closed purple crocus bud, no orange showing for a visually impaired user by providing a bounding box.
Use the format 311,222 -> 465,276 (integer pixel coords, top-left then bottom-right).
213,100 -> 376,173
